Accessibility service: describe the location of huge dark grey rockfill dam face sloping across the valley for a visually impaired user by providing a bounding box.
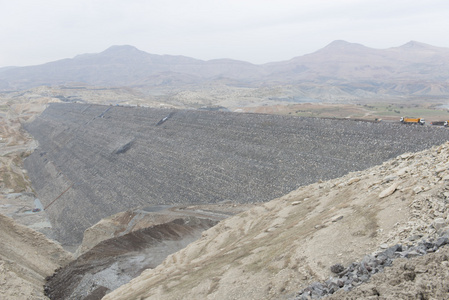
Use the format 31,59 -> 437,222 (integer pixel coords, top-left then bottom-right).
25,103 -> 449,244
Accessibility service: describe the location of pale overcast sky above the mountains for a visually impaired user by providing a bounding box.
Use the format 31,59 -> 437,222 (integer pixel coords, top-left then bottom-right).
0,0 -> 449,67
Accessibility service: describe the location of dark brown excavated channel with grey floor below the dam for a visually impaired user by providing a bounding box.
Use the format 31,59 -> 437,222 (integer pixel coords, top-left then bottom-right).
44,217 -> 218,300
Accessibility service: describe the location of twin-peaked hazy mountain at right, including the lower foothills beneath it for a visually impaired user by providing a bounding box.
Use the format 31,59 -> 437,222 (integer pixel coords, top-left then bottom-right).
265,41 -> 449,98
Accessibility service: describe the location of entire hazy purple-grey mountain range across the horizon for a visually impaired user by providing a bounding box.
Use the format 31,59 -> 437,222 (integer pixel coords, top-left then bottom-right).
0,40 -> 449,98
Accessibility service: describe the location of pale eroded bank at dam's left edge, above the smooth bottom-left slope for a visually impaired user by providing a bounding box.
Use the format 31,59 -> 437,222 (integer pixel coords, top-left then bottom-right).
0,93 -> 57,231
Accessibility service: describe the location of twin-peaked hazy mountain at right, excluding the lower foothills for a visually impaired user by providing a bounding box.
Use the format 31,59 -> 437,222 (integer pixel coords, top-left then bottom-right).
267,41 -> 449,82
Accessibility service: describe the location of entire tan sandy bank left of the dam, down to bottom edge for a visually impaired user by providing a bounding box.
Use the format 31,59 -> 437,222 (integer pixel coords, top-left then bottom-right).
0,96 -> 72,300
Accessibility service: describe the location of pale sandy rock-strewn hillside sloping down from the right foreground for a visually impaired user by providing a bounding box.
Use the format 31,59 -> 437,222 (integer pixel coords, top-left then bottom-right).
104,143 -> 449,300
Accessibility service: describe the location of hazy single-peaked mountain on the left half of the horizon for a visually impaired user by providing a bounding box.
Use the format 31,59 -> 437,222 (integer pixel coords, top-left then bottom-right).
0,46 -> 257,89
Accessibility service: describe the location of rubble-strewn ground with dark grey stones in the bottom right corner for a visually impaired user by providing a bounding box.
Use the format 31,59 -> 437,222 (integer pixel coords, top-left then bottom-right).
293,236 -> 449,300
